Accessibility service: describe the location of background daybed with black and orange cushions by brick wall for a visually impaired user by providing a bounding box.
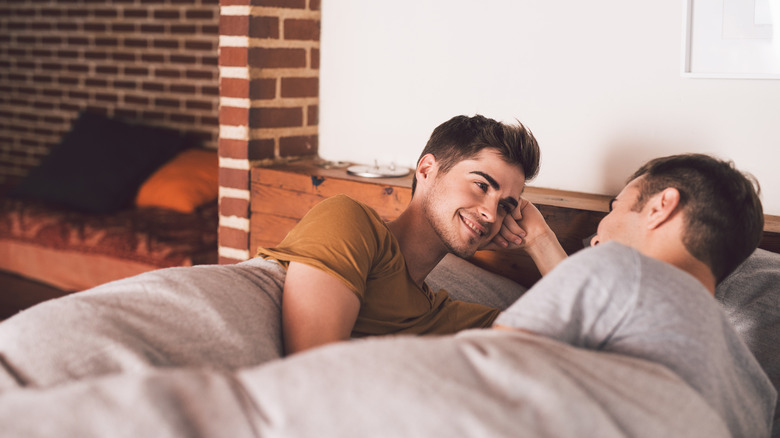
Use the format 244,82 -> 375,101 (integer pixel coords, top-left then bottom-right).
0,113 -> 219,291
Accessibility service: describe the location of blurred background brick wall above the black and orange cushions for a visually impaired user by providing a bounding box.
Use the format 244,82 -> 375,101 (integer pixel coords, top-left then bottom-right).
0,0 -> 219,183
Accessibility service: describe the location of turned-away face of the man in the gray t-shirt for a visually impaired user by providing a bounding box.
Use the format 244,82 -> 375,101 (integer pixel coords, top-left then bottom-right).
591,179 -> 642,247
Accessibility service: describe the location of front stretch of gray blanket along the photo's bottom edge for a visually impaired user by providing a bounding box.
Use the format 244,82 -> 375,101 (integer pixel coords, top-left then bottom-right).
0,330 -> 728,438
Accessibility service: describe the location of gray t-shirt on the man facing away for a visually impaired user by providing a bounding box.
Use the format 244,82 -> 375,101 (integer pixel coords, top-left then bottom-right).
495,243 -> 777,436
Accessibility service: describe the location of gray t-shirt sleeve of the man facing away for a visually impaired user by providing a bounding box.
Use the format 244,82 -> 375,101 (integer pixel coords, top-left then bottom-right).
495,244 -> 637,349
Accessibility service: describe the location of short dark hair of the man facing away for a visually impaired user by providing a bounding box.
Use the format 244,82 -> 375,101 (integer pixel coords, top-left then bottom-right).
630,154 -> 764,283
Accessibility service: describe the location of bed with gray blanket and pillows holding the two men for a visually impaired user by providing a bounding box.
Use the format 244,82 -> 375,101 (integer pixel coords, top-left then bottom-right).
0,163 -> 780,437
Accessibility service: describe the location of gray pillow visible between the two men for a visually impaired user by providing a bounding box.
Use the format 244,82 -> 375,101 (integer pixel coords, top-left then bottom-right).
425,254 -> 526,310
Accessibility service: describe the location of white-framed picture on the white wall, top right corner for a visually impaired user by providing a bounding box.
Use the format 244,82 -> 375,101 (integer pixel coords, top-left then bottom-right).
682,0 -> 780,79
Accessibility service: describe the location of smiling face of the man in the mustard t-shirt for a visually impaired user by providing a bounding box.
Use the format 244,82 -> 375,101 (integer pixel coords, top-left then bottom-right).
423,149 -> 525,257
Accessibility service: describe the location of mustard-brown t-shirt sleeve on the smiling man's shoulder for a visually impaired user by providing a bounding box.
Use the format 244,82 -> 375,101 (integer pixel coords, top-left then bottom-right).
257,195 -> 387,301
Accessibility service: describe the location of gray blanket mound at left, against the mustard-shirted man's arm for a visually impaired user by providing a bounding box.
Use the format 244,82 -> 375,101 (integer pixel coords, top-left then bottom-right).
0,259 -> 285,391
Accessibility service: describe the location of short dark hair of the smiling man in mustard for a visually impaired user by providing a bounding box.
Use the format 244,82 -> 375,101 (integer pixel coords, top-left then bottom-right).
412,115 -> 540,194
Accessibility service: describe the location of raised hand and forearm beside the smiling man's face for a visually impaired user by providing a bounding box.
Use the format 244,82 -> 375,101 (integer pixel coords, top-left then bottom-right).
482,199 -> 566,275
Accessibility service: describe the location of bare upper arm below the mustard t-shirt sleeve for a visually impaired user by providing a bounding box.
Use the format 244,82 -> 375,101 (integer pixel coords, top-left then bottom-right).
282,262 -> 360,354
